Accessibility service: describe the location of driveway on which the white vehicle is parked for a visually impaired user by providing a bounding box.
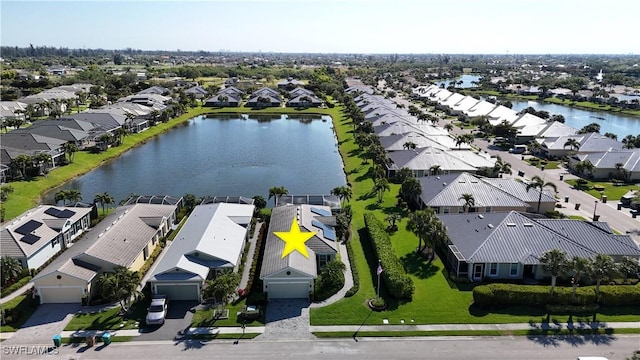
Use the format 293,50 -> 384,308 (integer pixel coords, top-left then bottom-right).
133,301 -> 198,341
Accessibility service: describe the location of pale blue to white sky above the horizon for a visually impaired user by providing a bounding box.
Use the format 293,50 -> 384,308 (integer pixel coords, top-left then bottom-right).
0,0 -> 640,55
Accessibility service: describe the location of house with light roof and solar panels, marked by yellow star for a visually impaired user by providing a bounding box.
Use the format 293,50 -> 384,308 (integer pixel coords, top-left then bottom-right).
260,204 -> 346,299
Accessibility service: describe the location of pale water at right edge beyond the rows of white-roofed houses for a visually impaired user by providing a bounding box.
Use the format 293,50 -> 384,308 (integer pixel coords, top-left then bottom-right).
511,101 -> 640,140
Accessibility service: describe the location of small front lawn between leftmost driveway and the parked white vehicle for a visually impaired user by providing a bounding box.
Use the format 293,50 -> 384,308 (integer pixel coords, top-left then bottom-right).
64,303 -> 146,331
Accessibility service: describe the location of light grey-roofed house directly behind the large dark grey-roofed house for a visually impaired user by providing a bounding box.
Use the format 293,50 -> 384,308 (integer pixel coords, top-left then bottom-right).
418,172 -> 556,214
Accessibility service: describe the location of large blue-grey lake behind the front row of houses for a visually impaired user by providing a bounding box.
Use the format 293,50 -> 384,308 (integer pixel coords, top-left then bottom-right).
43,114 -> 346,204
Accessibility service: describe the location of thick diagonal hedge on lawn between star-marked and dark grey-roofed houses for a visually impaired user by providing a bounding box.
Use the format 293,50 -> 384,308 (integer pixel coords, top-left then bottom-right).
364,213 -> 415,299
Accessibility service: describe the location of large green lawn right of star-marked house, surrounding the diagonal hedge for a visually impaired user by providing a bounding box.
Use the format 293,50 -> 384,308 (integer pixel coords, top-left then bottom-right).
311,103 -> 640,325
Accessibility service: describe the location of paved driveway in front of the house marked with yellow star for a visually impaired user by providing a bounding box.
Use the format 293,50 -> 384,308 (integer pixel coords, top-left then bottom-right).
257,299 -> 315,340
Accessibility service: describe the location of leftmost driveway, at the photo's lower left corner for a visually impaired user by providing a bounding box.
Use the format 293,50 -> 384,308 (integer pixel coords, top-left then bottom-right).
2,304 -> 82,345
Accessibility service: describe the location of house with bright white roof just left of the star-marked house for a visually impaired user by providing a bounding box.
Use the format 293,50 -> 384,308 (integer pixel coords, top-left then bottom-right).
148,203 -> 254,300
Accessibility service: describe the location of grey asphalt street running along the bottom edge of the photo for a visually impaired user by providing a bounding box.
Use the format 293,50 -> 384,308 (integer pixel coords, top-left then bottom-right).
0,335 -> 640,360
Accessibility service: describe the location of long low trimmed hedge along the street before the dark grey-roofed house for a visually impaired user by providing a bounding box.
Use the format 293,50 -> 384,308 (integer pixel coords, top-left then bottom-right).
473,284 -> 640,307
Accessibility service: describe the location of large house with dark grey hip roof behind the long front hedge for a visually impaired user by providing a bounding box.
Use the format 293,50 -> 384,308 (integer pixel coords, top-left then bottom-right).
438,211 -> 640,281
